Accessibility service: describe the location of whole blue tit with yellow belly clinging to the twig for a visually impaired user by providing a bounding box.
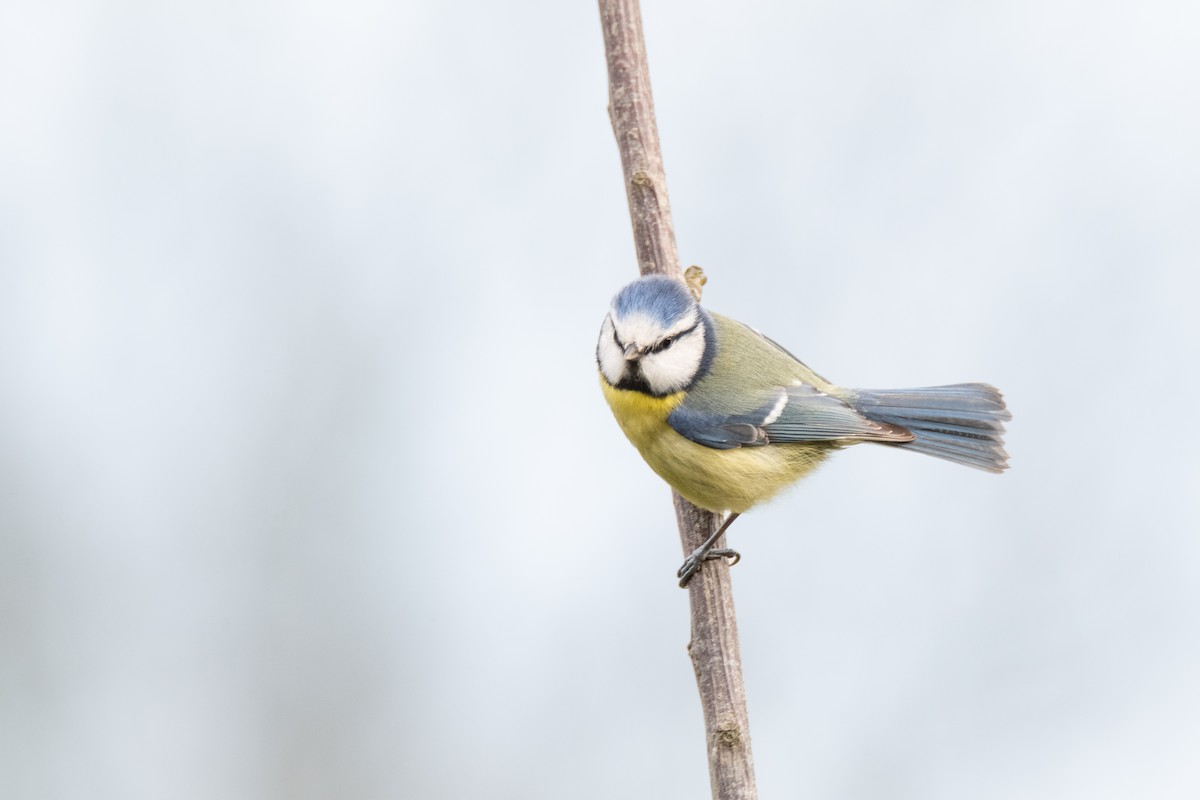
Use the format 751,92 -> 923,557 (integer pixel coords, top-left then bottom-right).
596,276 -> 1012,585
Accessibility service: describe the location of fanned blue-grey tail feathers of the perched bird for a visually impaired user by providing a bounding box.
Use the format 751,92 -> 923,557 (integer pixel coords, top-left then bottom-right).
851,384 -> 1013,473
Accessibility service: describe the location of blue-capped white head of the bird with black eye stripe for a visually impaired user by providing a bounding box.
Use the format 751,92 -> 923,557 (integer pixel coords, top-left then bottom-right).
596,276 -> 715,397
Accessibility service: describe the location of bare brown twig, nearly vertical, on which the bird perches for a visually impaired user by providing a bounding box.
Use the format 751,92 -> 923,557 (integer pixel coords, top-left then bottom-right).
599,0 -> 757,800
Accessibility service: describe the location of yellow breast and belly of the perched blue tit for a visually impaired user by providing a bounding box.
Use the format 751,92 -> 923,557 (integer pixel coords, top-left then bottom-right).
600,375 -> 838,513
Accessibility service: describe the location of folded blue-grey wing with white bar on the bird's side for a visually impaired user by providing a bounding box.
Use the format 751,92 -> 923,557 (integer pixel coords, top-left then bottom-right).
667,384 -> 913,450
